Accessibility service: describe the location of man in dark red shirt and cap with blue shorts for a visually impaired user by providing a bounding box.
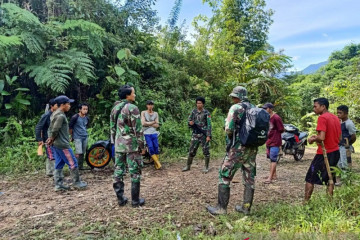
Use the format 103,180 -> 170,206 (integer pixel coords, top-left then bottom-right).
262,103 -> 284,184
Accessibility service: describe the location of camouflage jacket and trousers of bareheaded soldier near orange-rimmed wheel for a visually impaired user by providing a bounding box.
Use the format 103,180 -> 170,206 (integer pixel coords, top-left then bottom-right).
110,100 -> 144,182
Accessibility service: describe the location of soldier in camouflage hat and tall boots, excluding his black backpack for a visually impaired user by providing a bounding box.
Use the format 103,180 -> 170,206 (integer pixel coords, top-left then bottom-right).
207,86 -> 258,215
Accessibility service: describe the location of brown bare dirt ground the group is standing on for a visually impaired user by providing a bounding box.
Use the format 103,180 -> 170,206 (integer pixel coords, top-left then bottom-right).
0,149 -> 350,239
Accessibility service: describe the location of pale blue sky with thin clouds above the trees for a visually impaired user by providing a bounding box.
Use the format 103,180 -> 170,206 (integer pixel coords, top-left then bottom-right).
155,0 -> 360,70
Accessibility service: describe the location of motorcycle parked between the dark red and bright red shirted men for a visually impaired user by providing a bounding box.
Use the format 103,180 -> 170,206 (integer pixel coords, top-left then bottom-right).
278,124 -> 309,161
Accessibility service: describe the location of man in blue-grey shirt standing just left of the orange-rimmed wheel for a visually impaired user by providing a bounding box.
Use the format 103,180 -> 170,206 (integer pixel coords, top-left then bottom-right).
69,103 -> 90,170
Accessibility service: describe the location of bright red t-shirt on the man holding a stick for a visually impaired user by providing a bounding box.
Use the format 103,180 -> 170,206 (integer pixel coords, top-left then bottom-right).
316,112 -> 341,154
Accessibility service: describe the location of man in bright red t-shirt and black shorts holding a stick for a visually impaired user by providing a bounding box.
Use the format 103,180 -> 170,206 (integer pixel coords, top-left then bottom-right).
305,98 -> 341,202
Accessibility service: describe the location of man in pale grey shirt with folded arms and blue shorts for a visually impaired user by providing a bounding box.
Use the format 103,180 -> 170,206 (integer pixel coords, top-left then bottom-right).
141,100 -> 161,169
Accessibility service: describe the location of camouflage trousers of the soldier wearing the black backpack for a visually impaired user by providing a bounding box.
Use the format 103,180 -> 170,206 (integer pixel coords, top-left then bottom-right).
219,146 -> 258,189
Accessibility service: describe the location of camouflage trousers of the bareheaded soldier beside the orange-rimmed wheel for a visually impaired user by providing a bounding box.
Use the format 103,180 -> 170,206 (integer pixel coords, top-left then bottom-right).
114,152 -> 143,182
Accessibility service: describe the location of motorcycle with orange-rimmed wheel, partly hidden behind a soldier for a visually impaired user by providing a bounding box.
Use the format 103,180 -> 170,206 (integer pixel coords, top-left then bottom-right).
85,140 -> 154,169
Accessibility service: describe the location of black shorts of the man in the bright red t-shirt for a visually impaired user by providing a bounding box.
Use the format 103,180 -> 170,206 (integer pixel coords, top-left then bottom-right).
305,150 -> 340,185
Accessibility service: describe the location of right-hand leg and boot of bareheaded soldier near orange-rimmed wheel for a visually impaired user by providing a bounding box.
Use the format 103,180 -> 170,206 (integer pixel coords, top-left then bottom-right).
126,152 -> 145,207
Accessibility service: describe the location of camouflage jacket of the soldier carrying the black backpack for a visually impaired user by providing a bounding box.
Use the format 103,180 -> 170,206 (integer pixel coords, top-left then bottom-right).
225,102 -> 255,147
